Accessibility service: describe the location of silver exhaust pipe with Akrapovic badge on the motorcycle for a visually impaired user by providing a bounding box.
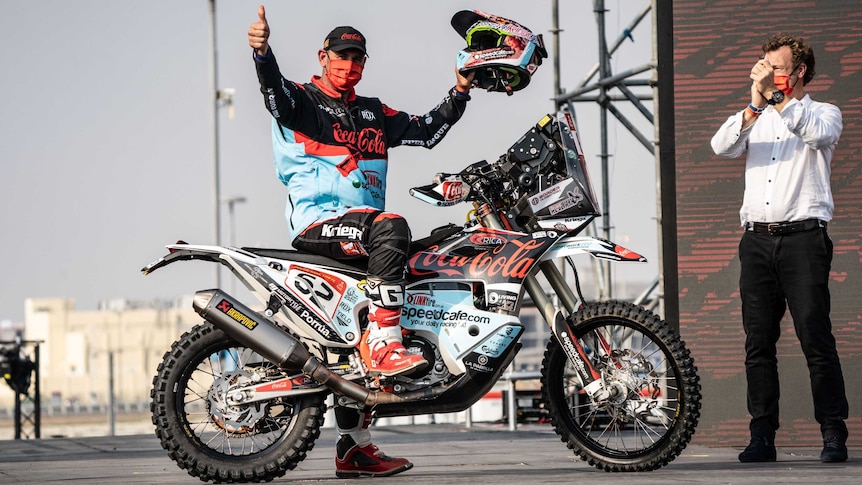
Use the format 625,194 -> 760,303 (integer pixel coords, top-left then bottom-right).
192,289 -> 416,407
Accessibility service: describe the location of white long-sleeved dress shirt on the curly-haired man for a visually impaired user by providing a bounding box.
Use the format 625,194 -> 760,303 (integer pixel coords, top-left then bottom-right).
711,94 -> 843,225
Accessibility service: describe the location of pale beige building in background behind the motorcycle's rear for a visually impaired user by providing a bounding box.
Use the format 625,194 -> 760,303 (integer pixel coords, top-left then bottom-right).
0,296 -> 197,413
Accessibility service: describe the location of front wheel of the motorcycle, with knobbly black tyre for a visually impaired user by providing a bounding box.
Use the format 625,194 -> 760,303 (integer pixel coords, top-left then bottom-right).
542,301 -> 701,471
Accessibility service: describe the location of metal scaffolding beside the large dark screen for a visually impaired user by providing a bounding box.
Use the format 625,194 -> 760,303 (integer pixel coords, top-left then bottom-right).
551,0 -> 678,324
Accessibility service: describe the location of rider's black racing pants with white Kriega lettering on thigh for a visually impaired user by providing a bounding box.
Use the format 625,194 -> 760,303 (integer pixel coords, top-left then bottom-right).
293,209 -> 410,284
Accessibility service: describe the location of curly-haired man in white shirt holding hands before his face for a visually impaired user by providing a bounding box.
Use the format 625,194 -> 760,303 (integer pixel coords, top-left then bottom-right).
712,34 -> 848,462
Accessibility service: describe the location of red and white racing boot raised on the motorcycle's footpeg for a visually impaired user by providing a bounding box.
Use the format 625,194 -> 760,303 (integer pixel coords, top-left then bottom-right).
360,308 -> 428,376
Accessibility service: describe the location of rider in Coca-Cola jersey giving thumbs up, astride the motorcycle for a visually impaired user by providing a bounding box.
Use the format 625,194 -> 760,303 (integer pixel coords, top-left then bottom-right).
248,5 -> 473,478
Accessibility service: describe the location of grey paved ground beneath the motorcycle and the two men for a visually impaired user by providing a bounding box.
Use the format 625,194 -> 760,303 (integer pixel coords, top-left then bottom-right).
0,423 -> 862,485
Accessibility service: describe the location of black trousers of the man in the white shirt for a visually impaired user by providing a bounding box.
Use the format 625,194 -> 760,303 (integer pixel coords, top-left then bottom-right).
739,228 -> 848,437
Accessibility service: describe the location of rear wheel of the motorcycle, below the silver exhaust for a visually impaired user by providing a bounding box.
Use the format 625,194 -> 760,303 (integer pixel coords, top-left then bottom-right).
150,324 -> 326,483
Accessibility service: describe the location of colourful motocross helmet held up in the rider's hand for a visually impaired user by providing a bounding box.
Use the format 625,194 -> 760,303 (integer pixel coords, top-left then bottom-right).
452,10 -> 548,95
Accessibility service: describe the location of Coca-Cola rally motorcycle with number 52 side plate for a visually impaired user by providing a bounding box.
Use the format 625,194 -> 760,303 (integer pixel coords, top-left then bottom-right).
142,111 -> 701,482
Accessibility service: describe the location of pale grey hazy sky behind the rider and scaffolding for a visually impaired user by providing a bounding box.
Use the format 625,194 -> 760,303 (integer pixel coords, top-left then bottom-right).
0,0 -> 658,322
